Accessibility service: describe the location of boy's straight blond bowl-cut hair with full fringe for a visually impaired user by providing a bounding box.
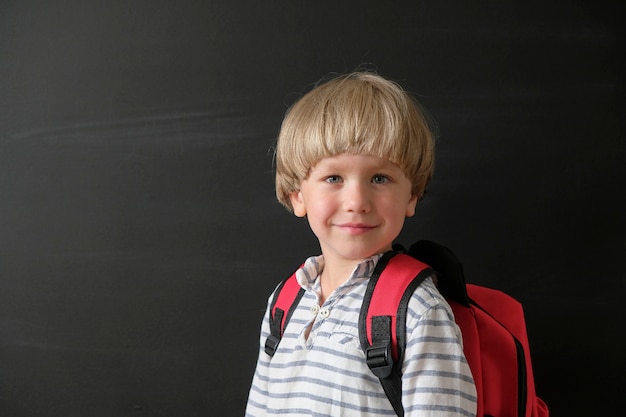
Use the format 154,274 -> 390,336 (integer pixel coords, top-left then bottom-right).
275,72 -> 434,211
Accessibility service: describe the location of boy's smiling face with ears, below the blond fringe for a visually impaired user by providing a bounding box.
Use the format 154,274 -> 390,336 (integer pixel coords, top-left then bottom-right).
290,154 -> 417,262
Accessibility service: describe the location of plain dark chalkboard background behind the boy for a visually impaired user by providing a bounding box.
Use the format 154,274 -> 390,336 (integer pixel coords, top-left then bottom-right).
0,0 -> 626,417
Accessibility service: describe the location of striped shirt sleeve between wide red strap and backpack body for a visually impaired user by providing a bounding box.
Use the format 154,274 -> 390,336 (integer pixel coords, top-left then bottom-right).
402,280 -> 476,417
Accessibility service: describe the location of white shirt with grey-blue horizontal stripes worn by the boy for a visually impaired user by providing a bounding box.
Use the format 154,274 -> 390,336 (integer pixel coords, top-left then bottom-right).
246,255 -> 476,417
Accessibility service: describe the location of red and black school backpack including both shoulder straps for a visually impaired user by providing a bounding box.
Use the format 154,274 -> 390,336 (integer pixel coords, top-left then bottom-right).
265,240 -> 549,417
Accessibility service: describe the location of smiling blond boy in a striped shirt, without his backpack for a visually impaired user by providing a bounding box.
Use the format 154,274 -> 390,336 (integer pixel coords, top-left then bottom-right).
246,72 -> 476,417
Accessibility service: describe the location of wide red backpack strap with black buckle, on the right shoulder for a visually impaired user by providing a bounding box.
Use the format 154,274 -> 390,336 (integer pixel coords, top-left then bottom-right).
359,252 -> 433,416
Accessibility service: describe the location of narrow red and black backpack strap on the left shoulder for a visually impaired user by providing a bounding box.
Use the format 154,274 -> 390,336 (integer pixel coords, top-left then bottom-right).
265,272 -> 304,356
